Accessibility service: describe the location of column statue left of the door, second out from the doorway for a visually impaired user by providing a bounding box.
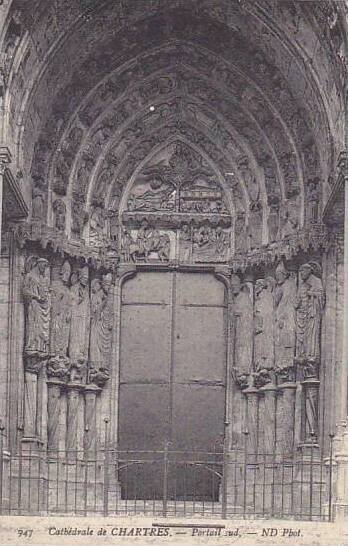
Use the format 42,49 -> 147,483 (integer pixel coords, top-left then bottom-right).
69,266 -> 90,379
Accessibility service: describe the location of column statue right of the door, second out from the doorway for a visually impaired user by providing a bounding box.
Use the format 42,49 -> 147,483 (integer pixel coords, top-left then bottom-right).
254,277 -> 274,383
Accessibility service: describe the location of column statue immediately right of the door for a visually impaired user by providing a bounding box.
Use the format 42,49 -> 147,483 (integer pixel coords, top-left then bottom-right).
231,275 -> 253,388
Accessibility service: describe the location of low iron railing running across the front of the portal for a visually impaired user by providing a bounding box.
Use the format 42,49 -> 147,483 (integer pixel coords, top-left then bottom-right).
0,436 -> 333,521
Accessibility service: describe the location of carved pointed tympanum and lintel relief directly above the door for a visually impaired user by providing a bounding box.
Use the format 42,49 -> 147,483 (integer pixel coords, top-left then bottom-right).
121,142 -> 231,263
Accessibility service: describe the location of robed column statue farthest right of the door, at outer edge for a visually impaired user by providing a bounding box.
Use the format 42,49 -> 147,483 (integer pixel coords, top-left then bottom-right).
295,262 -> 325,365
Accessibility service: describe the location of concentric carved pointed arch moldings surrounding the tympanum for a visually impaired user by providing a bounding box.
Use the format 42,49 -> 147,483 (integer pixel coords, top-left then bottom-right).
1,1 -> 338,268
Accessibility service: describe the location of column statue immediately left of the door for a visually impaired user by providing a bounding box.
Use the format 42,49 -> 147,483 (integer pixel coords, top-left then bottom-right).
89,273 -> 113,370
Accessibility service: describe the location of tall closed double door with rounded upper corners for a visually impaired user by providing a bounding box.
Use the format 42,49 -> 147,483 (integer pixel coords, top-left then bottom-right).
118,271 -> 227,500
